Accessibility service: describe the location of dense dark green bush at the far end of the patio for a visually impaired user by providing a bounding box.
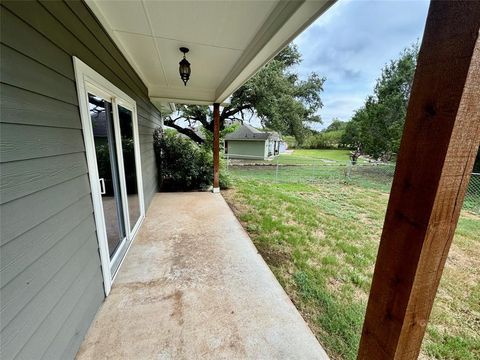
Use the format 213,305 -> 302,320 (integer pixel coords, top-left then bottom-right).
153,128 -> 229,191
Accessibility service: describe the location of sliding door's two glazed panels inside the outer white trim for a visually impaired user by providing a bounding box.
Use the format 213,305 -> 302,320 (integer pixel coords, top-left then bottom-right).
88,89 -> 143,276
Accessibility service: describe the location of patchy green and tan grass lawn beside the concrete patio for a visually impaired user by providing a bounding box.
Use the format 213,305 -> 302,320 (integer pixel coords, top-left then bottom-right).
223,150 -> 480,360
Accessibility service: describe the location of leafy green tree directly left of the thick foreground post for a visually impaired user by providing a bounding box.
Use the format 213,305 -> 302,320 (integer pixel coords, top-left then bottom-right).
343,44 -> 418,159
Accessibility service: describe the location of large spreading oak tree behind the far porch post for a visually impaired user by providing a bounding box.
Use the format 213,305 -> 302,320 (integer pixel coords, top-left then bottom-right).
164,45 -> 325,144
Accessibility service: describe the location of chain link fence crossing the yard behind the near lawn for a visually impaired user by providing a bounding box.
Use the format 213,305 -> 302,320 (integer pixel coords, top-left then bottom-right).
226,153 -> 480,214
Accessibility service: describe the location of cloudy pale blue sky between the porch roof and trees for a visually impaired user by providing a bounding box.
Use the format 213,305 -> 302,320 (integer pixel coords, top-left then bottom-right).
294,0 -> 429,129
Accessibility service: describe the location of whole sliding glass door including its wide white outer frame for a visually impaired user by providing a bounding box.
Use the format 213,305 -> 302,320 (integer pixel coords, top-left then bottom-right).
73,57 -> 145,295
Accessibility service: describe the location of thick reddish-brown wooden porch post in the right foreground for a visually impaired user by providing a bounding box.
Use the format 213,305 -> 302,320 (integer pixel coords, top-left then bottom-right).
358,0 -> 480,360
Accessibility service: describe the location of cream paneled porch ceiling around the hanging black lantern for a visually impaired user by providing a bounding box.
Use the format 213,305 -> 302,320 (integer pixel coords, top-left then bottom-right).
87,0 -> 335,106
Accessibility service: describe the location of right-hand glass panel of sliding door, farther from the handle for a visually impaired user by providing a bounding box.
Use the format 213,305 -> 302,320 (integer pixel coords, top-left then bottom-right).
118,105 -> 141,231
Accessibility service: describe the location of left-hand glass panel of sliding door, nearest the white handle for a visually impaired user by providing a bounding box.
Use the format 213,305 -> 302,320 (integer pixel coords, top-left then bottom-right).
88,94 -> 126,259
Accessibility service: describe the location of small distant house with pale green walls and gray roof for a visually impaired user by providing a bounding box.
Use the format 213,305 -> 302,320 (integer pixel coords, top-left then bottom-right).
224,124 -> 281,160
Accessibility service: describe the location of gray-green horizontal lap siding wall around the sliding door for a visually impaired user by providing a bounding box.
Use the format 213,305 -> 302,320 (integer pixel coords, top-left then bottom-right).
0,1 -> 161,359
